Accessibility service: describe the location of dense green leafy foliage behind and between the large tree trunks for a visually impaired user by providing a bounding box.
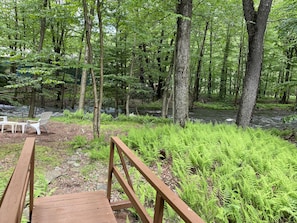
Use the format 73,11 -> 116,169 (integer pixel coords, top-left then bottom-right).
0,0 -> 297,108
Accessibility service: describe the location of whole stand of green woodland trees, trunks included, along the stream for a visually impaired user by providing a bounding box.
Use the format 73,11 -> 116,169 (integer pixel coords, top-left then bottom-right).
0,0 -> 297,134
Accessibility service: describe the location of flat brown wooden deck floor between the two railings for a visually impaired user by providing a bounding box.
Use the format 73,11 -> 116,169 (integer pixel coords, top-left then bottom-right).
32,191 -> 117,223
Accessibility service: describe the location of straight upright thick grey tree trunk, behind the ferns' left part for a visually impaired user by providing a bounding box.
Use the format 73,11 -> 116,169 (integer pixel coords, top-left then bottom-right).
174,0 -> 192,127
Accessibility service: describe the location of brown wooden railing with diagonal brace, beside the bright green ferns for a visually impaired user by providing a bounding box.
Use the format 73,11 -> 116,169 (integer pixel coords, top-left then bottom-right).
107,137 -> 204,223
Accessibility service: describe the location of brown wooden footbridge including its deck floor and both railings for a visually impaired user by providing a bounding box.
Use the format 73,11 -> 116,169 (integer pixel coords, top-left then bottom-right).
0,137 -> 203,223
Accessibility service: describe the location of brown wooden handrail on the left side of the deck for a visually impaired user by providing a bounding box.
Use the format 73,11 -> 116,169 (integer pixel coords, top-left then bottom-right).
0,137 -> 35,223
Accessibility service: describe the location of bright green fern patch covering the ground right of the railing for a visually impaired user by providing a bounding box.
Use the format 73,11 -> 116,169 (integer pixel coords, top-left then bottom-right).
114,123 -> 297,222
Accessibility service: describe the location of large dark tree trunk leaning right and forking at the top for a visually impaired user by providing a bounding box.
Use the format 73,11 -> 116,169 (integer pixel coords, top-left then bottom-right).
236,0 -> 272,127
